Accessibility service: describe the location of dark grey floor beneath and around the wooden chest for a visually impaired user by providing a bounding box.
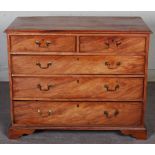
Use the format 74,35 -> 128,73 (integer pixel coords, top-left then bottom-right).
0,82 -> 155,144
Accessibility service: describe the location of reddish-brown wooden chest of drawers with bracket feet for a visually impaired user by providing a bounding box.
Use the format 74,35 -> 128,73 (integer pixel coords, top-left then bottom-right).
6,17 -> 150,139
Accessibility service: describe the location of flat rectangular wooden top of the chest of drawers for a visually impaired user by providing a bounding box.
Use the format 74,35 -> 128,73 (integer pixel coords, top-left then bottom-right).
5,16 -> 151,33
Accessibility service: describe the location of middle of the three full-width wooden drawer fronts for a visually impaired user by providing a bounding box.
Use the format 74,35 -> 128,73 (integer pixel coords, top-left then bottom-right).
13,77 -> 143,100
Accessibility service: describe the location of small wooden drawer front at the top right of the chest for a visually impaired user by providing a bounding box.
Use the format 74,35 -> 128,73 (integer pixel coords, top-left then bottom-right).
80,36 -> 145,54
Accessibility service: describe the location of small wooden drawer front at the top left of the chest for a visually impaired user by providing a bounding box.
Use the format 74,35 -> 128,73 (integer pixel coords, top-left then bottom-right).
11,35 -> 76,52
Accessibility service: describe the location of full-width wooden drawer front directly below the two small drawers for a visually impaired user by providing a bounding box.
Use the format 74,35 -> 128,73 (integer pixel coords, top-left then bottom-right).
12,56 -> 144,75
